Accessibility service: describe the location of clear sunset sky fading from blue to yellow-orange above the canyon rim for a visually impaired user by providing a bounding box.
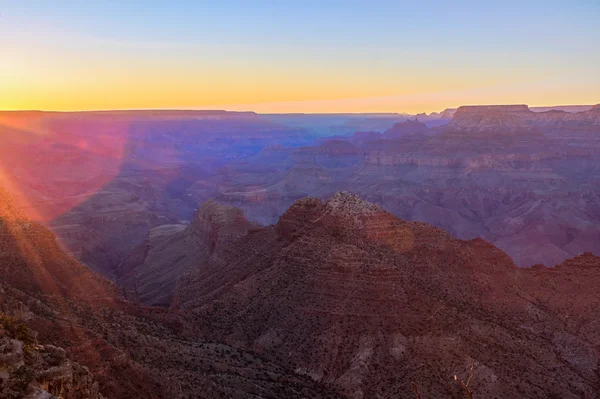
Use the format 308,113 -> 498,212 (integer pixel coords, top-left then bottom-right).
0,0 -> 600,113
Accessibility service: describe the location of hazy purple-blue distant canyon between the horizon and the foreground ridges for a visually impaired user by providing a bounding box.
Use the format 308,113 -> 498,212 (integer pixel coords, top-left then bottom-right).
0,105 -> 600,279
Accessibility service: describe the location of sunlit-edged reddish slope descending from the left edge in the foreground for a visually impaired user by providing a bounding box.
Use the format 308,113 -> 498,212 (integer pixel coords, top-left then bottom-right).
0,186 -> 338,399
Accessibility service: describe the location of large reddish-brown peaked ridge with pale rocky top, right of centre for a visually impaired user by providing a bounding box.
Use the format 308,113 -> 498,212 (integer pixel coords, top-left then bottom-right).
176,193 -> 600,398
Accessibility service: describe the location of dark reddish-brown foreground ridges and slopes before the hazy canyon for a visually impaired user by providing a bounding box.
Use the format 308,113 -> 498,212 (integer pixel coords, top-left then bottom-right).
0,190 -> 600,399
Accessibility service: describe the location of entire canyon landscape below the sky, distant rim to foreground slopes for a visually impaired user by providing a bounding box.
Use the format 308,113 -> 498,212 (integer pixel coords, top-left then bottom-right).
0,105 -> 600,399
